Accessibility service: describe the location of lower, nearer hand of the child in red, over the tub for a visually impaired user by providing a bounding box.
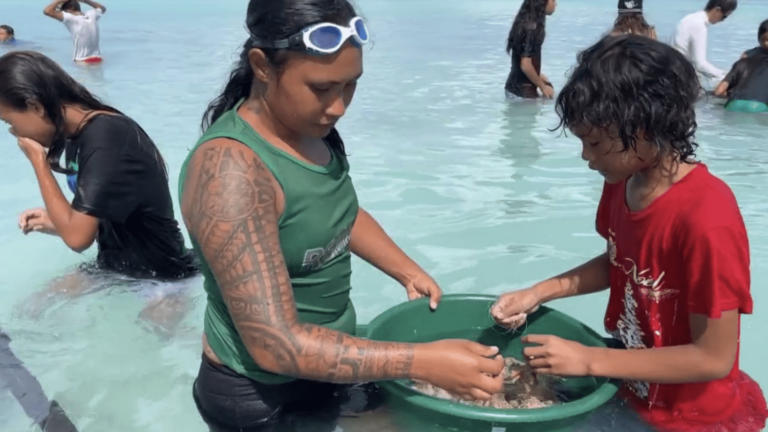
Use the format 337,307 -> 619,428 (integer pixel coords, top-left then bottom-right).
523,335 -> 591,376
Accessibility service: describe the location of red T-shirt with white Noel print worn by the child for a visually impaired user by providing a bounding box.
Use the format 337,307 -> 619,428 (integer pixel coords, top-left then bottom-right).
597,164 -> 768,432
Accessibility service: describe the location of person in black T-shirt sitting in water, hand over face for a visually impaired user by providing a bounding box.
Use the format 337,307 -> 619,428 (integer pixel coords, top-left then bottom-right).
0,51 -> 199,334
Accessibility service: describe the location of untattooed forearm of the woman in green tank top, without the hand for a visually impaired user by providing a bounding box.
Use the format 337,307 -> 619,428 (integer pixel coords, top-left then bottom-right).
350,208 -> 425,286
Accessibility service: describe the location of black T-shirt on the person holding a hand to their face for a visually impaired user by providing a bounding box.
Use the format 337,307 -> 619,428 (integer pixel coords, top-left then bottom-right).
66,114 -> 199,279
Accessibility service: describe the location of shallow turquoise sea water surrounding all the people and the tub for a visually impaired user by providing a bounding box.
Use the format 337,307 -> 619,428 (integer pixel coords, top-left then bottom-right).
0,0 -> 768,432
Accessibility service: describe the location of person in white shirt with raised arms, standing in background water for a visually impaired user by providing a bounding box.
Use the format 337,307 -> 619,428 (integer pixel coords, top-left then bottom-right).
43,0 -> 107,63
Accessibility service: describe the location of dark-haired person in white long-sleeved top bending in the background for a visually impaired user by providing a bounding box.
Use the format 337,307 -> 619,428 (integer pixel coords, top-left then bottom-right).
672,0 -> 738,83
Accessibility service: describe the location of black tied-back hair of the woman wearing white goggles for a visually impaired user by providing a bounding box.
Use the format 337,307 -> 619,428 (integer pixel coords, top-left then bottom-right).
202,0 -> 357,153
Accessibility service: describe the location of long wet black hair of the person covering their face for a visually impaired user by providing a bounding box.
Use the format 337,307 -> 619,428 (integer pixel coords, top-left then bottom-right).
0,51 -> 120,174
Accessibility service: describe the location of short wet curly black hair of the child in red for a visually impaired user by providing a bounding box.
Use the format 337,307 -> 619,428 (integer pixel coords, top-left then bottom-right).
555,34 -> 702,162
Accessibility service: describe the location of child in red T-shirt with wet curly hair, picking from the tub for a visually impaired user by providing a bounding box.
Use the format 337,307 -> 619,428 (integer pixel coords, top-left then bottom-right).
491,35 -> 768,432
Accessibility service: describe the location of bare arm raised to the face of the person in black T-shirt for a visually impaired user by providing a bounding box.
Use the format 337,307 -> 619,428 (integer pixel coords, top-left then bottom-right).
30,152 -> 99,252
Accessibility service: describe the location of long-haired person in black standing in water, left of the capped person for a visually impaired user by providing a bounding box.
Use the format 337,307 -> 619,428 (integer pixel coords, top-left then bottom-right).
504,0 -> 557,98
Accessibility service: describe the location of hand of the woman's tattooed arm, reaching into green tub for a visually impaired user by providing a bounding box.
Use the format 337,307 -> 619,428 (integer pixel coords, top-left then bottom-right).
413,339 -> 504,400
